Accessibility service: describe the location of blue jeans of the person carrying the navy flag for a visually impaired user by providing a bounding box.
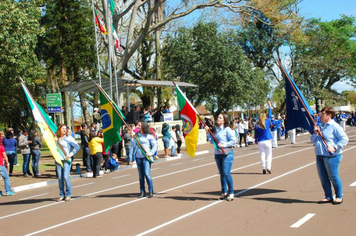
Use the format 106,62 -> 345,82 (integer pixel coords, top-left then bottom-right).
316,154 -> 343,200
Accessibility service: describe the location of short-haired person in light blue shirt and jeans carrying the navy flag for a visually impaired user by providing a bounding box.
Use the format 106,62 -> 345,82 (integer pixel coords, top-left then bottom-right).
310,107 -> 349,205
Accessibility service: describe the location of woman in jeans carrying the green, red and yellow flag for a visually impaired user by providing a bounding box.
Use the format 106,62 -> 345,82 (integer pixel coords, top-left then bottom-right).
205,114 -> 236,202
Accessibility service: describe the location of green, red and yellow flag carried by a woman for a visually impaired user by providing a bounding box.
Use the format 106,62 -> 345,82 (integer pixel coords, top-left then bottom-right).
176,85 -> 199,157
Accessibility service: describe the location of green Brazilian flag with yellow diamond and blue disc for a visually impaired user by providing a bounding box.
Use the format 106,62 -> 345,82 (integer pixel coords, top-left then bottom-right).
99,89 -> 125,152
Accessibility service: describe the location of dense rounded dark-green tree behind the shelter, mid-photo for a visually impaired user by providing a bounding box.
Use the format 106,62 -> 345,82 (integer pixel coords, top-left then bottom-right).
163,23 -> 268,114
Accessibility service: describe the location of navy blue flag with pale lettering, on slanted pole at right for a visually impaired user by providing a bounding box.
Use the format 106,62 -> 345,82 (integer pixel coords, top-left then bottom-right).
280,64 -> 314,134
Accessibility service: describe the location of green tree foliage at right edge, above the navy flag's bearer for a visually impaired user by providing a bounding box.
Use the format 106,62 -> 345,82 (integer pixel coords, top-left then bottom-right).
292,15 -> 356,110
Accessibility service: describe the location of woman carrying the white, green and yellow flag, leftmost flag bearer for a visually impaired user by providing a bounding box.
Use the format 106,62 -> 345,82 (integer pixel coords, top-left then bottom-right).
56,124 -> 79,202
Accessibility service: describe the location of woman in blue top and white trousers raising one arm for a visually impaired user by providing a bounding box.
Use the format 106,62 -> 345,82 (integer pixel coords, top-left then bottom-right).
255,101 -> 272,174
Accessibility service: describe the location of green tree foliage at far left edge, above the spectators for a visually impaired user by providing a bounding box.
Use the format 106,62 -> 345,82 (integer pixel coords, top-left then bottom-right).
0,0 -> 44,129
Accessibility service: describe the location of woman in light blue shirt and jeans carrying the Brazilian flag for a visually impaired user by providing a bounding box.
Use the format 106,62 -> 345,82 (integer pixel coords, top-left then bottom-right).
133,122 -> 157,198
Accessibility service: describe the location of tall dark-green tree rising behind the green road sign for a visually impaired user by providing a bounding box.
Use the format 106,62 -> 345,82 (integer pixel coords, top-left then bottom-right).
41,0 -> 96,125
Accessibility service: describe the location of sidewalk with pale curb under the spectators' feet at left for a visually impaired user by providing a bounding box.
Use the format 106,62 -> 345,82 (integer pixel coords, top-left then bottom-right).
6,143 -> 213,193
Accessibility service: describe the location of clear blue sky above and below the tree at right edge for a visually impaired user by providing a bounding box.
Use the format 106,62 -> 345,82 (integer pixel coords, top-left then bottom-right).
299,0 -> 356,92
